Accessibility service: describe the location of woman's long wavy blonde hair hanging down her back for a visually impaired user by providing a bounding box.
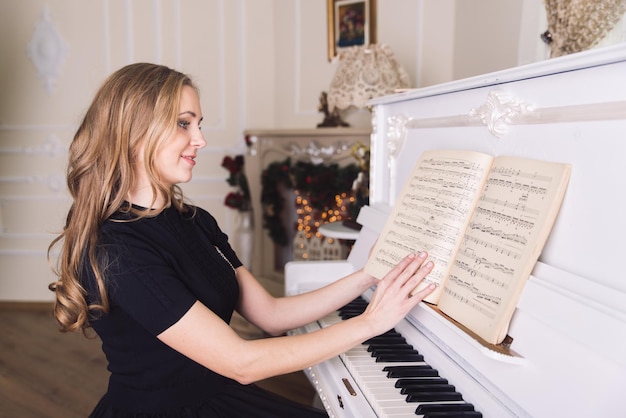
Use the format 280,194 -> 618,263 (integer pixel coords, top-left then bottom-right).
48,63 -> 195,331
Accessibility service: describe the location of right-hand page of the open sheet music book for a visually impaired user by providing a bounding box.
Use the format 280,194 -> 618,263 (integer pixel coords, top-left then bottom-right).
439,157 -> 570,344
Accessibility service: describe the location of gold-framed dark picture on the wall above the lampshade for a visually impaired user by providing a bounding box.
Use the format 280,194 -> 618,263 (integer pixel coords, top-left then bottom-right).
327,0 -> 376,61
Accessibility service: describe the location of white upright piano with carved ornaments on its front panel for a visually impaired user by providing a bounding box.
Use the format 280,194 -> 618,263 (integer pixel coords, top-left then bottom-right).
285,44 -> 626,418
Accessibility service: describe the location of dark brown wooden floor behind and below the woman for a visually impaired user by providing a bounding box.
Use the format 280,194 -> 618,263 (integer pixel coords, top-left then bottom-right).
0,278 -> 315,418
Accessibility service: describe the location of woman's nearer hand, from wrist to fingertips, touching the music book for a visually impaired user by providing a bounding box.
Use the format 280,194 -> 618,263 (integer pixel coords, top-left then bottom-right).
362,252 -> 437,335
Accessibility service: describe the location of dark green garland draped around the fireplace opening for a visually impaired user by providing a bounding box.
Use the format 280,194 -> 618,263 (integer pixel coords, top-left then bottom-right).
261,158 -> 361,246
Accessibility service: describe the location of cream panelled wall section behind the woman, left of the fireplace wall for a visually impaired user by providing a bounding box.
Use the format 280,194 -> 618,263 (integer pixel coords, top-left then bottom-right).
0,0 -> 254,300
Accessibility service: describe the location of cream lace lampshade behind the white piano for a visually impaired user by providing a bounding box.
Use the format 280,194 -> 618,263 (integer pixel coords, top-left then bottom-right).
328,44 -> 410,111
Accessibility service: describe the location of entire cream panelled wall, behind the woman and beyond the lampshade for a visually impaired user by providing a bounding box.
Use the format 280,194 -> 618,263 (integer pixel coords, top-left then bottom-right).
0,0 -> 560,300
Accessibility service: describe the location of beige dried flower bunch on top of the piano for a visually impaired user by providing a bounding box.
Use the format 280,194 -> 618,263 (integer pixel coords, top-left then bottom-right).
541,0 -> 626,57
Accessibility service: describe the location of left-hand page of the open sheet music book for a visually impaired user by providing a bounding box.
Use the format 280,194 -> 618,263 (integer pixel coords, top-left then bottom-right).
365,150 -> 493,303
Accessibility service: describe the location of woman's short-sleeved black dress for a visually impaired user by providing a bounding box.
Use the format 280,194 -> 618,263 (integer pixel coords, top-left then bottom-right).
84,208 -> 326,418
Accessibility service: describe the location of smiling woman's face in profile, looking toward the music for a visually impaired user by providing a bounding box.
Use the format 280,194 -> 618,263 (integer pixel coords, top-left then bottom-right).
155,86 -> 206,186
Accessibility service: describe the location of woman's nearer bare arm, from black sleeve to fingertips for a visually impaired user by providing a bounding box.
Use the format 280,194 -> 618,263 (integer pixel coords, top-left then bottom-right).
158,251 -> 434,384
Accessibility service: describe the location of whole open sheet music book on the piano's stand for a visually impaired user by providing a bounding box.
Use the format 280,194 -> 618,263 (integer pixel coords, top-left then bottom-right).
365,150 -> 571,344
